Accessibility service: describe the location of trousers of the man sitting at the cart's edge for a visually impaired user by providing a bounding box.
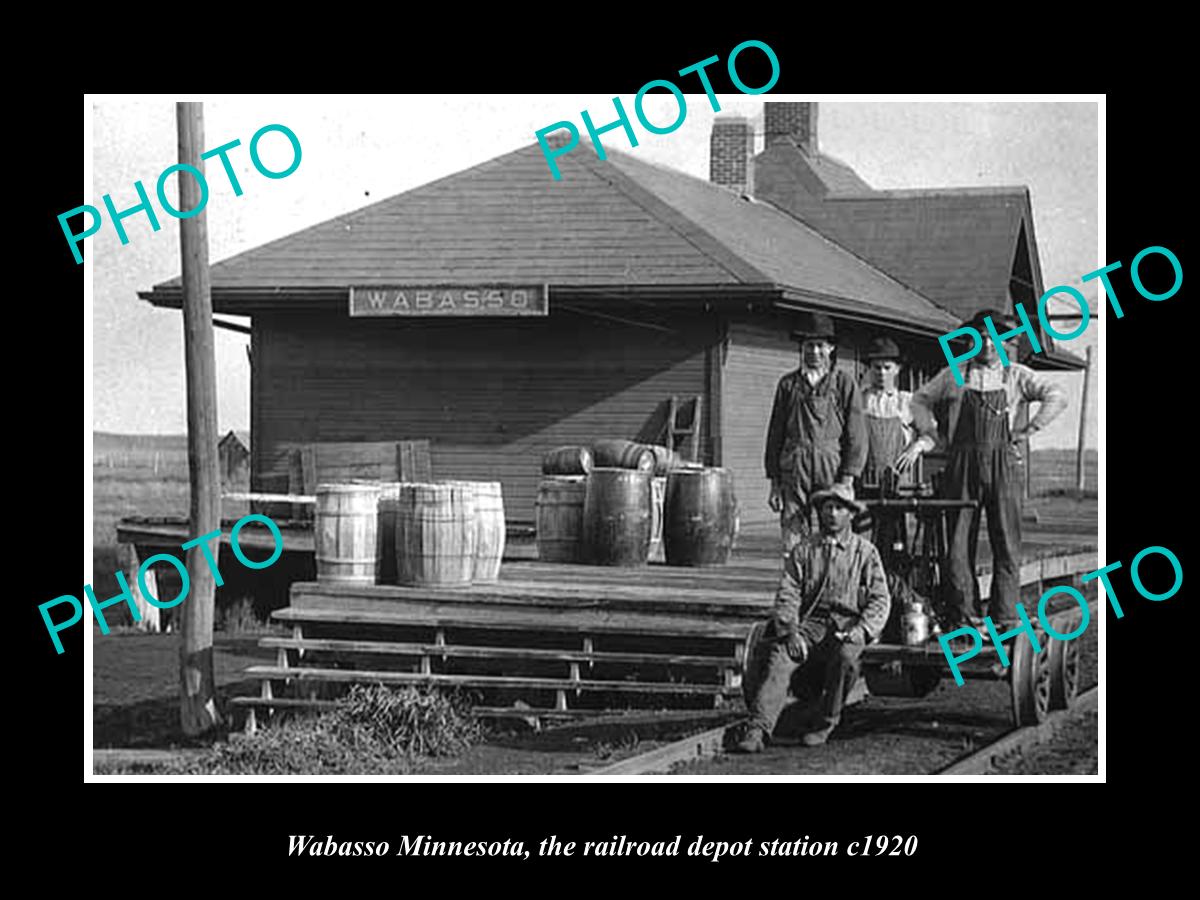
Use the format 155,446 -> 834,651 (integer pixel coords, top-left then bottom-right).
750,619 -> 863,734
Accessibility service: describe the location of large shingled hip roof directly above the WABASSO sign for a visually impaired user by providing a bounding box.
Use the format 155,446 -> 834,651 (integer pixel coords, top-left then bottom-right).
142,144 -> 954,331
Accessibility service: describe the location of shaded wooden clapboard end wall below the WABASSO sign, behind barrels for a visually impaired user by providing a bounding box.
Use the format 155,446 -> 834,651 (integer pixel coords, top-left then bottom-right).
252,313 -> 715,521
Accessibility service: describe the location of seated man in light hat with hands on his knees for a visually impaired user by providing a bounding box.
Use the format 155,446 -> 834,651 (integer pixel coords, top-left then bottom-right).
738,484 -> 892,754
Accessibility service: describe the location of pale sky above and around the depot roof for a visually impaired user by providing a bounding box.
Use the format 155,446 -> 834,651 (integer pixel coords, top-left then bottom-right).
87,94 -> 1111,448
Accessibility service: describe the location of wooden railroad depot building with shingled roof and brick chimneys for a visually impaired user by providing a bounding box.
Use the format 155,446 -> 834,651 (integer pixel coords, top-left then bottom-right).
140,103 -> 1082,523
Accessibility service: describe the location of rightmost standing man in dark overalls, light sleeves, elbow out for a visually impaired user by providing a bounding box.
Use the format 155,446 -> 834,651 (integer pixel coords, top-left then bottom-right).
898,310 -> 1067,626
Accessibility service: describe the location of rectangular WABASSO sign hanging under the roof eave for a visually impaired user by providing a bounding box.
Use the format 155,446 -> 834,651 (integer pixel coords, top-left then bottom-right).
350,284 -> 550,317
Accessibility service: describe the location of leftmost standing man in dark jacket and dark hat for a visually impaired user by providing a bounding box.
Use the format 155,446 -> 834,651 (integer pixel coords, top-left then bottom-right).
764,313 -> 866,553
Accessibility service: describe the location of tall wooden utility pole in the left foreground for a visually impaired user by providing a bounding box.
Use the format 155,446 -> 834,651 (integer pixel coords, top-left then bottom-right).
175,103 -> 221,736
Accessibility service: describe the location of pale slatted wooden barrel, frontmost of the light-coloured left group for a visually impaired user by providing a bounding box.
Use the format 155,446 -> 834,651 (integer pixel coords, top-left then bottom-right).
396,484 -> 476,586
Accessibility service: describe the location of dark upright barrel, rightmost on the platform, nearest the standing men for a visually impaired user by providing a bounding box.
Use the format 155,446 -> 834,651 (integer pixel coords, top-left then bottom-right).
662,468 -> 738,565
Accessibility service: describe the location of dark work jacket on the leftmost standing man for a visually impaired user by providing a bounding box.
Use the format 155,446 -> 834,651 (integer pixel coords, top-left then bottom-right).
763,368 -> 866,493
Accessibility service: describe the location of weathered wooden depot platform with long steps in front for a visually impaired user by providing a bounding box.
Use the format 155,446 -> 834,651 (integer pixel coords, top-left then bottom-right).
238,528 -> 1097,728
